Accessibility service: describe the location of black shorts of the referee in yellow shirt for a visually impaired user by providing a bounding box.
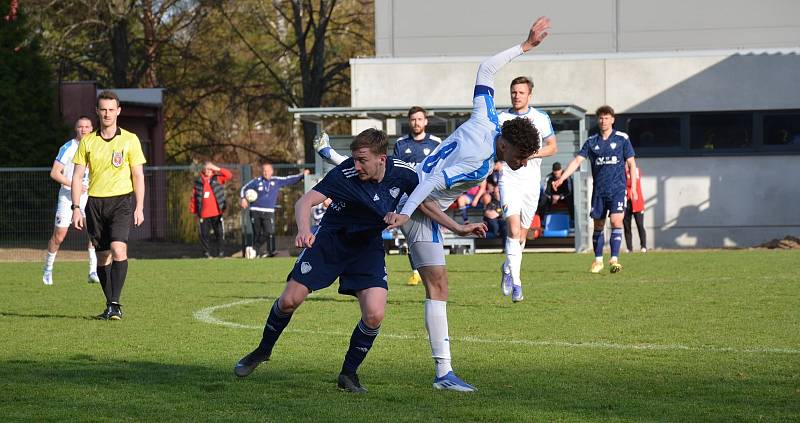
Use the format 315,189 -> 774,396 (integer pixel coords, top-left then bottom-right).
86,193 -> 133,251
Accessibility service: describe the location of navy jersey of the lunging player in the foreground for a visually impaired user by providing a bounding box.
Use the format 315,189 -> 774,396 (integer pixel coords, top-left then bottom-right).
313,157 -> 419,235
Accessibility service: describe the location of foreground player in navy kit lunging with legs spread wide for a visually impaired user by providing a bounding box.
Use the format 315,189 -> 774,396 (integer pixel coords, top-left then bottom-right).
234,129 -> 419,392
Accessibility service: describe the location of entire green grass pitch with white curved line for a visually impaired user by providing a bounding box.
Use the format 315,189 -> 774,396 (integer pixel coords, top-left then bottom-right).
0,250 -> 800,422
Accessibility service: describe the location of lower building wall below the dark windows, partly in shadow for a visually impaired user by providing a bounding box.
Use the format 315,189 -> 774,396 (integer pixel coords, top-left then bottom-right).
633,156 -> 800,248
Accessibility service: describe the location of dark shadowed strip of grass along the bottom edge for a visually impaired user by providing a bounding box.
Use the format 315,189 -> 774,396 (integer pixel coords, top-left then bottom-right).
0,351 -> 800,422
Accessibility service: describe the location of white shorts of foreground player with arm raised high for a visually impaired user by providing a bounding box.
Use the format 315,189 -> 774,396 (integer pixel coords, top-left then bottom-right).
400,210 -> 445,270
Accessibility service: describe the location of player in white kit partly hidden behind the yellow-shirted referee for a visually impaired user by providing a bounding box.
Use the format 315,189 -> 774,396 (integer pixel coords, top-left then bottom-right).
42,116 -> 100,285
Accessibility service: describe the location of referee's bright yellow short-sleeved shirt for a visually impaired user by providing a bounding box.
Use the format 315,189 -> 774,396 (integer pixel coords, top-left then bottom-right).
72,127 -> 146,197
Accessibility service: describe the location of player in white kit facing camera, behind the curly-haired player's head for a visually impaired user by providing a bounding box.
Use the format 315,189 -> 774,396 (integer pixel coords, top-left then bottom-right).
498,76 -> 558,303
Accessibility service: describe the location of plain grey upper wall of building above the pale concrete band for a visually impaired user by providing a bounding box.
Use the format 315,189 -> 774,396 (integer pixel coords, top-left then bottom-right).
375,0 -> 800,57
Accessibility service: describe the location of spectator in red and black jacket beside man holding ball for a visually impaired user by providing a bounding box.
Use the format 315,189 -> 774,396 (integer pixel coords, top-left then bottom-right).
189,162 -> 233,258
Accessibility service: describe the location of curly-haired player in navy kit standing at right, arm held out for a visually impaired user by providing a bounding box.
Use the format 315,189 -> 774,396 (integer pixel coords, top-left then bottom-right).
553,106 -> 639,273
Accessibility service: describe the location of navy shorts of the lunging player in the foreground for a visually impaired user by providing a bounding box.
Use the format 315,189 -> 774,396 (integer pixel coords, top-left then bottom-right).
286,227 -> 389,295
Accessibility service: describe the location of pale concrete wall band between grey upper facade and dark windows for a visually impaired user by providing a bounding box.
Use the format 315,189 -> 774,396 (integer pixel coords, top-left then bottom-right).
351,50 -> 800,113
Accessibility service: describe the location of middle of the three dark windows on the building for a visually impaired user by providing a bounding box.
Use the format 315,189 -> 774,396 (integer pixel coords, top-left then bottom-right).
689,113 -> 753,151
